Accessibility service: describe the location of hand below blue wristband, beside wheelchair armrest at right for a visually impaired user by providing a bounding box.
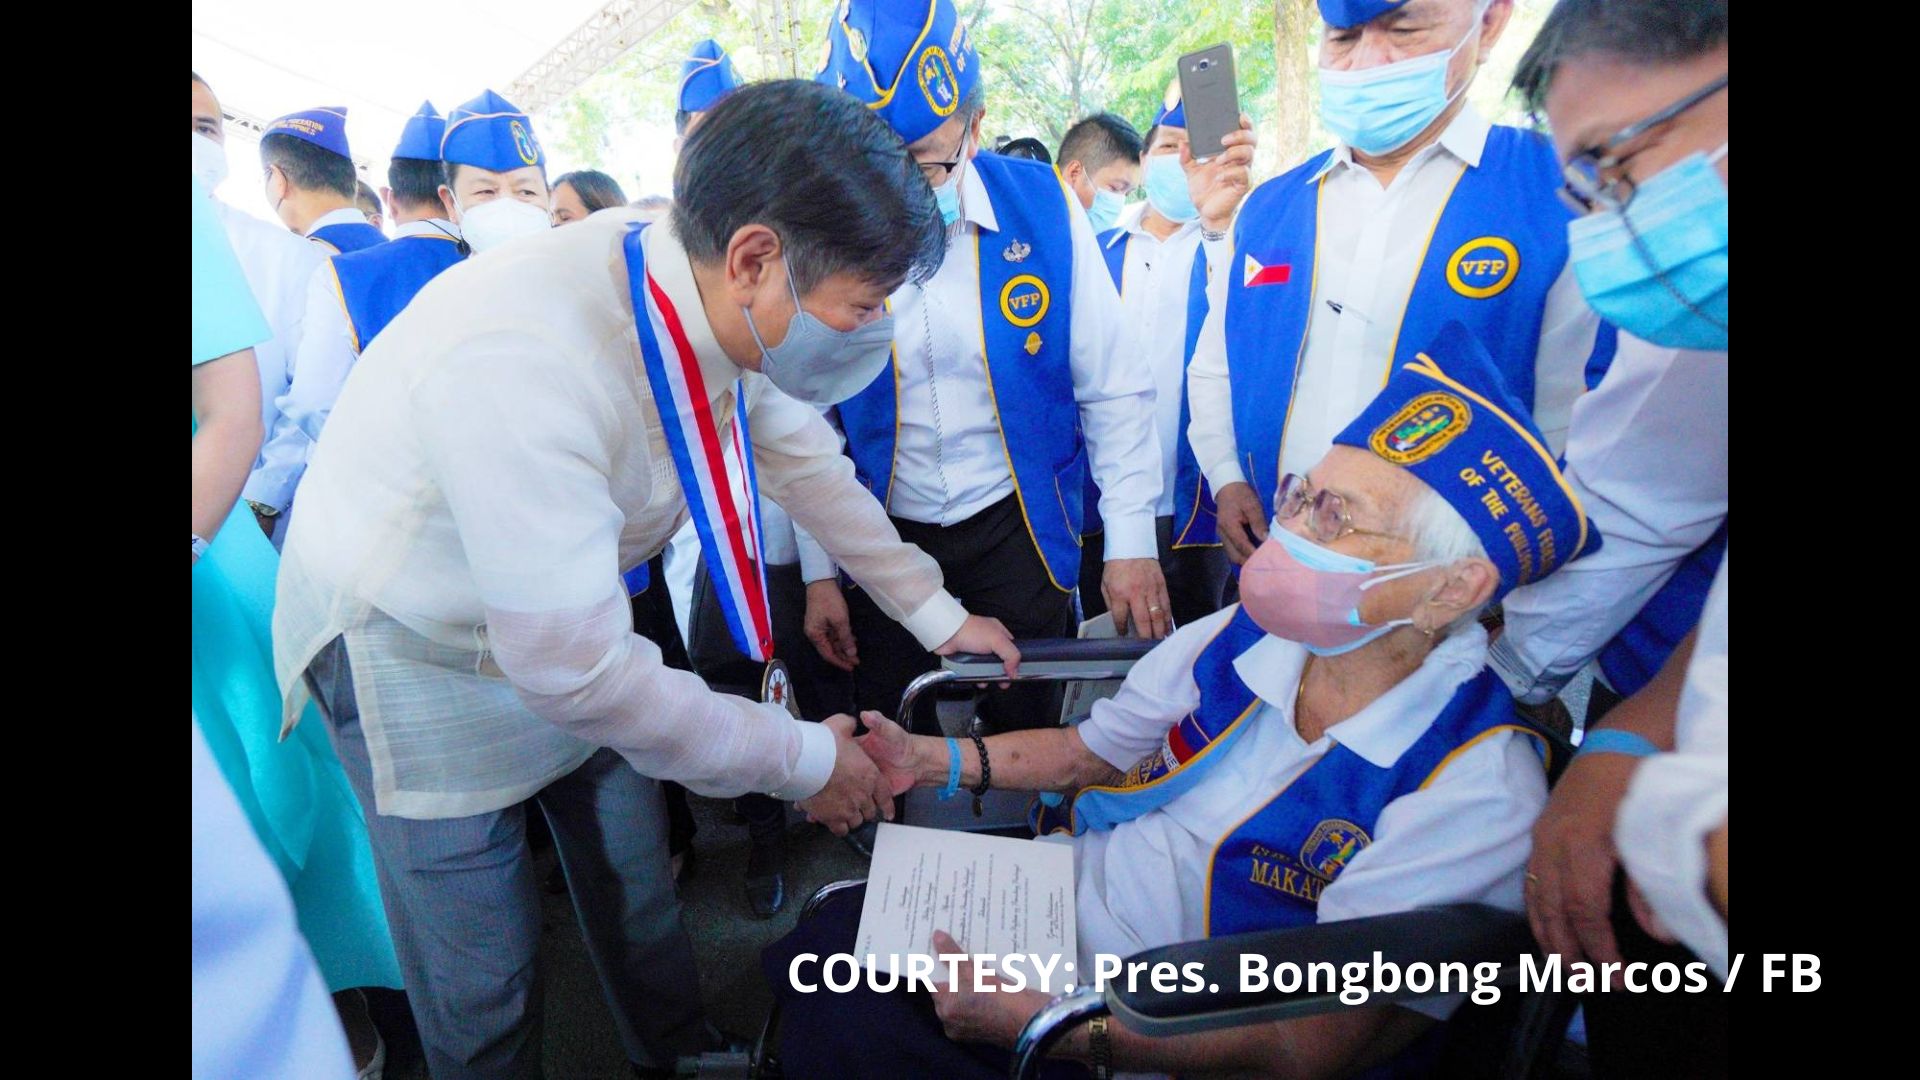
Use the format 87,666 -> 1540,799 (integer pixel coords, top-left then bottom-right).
1526,753 -> 1640,963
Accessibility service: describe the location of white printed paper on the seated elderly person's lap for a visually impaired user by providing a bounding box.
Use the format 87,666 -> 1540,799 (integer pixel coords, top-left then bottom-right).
852,822 -> 1075,974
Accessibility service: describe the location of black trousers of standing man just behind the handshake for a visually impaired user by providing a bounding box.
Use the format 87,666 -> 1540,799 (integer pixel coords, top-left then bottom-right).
847,496 -> 1075,732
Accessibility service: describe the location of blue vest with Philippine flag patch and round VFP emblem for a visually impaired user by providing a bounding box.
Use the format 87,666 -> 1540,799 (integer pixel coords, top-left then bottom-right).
1225,127 -> 1611,515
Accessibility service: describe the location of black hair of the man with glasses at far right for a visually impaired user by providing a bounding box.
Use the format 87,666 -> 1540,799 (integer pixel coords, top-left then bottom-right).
1513,0 -> 1726,115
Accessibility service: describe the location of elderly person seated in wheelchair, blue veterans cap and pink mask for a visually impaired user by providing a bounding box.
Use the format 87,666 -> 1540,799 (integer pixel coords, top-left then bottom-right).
764,325 -> 1599,1080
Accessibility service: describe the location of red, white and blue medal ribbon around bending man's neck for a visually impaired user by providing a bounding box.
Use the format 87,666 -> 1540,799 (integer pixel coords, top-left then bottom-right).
626,227 -> 774,663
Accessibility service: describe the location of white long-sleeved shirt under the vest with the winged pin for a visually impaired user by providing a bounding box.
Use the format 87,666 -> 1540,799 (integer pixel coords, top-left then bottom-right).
803,167 -> 1160,563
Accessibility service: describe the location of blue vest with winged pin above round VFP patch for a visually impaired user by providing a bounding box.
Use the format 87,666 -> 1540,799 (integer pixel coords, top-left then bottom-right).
839,154 -> 1087,592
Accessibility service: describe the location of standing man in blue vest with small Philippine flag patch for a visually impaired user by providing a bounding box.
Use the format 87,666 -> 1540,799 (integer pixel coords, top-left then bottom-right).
1187,0 -> 1611,563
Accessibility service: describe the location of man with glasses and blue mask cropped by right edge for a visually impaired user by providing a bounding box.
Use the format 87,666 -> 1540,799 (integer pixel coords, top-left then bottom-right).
1500,0 -> 1730,1076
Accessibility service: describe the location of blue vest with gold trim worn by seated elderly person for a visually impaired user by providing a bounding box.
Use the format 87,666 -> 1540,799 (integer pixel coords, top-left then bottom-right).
1035,609 -> 1546,936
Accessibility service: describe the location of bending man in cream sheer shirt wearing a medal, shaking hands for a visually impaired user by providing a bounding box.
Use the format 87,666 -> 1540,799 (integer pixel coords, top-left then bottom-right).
275,81 -> 1018,1080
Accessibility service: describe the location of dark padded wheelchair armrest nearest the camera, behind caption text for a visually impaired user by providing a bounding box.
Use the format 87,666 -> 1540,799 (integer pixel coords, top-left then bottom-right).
1106,903 -> 1534,1036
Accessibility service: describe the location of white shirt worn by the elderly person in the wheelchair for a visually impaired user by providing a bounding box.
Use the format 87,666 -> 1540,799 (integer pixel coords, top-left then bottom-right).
1073,605 -> 1548,1017
